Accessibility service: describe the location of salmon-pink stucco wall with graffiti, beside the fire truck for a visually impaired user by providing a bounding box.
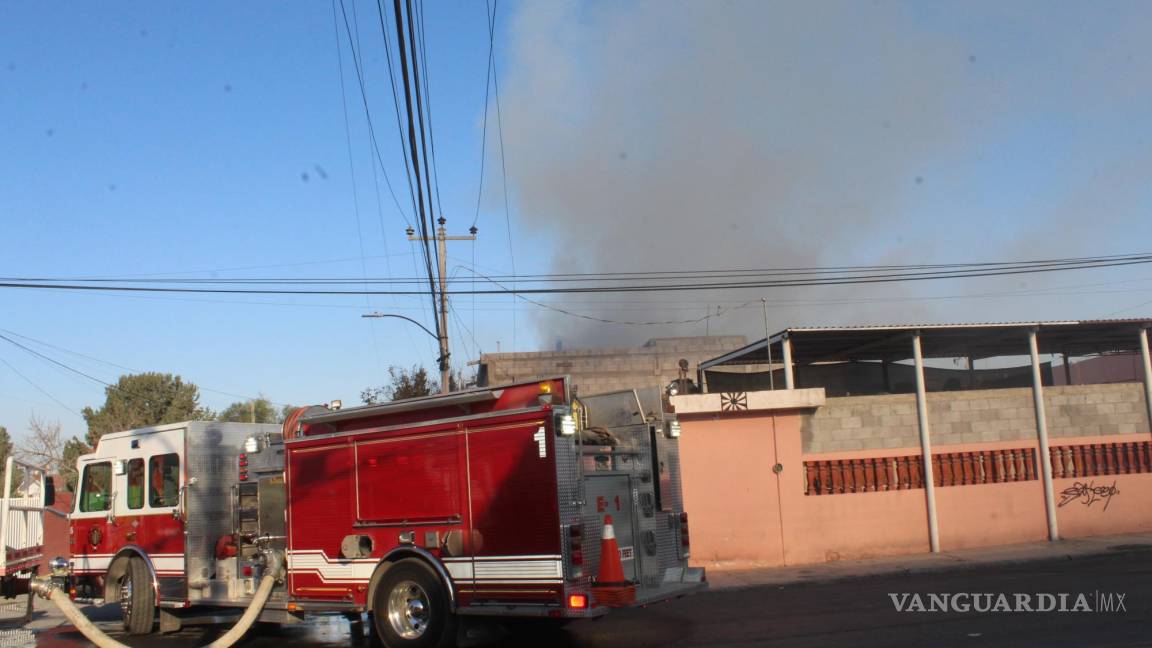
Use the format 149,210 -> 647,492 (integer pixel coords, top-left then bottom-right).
681,409 -> 1152,566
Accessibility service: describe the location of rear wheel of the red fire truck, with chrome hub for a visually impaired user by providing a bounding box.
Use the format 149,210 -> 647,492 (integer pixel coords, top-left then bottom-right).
372,558 -> 457,648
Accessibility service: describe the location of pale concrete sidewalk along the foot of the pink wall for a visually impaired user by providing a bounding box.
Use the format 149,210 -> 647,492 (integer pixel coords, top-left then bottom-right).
703,533 -> 1152,589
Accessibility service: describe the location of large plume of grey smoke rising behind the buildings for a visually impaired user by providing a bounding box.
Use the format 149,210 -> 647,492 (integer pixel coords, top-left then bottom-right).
501,1 -> 1146,346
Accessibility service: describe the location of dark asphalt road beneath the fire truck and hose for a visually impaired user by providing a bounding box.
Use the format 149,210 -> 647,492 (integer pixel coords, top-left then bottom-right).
11,547 -> 1152,648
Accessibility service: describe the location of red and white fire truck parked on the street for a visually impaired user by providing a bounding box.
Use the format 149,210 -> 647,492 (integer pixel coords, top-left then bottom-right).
56,378 -> 706,646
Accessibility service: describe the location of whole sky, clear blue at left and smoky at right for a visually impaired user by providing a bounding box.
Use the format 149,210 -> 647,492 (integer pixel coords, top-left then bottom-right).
0,0 -> 1152,436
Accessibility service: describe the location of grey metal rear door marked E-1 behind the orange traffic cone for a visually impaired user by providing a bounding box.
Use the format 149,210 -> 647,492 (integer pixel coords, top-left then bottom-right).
584,475 -> 643,581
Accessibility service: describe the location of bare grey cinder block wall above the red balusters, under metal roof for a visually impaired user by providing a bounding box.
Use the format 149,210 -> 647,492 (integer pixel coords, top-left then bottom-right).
801,383 -> 1150,453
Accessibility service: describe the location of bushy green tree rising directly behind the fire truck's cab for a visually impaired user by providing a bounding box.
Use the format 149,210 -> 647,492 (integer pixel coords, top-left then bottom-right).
83,372 -> 215,447
